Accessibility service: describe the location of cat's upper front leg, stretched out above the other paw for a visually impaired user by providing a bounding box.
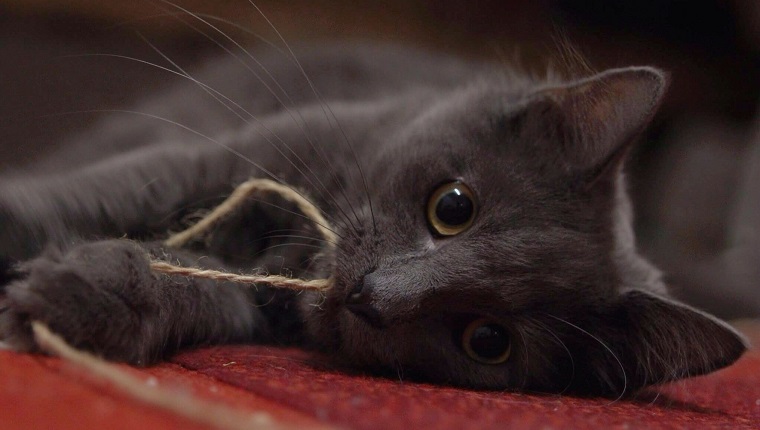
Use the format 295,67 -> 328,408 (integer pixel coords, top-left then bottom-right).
0,145 -> 243,260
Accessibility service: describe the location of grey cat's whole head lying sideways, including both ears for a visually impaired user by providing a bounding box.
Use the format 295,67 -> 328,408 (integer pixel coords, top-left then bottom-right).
300,67 -> 746,395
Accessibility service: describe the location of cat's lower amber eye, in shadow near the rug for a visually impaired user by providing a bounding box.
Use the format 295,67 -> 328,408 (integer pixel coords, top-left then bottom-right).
462,318 -> 512,364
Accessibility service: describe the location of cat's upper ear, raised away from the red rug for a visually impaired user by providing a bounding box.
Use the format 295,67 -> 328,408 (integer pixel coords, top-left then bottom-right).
539,67 -> 667,174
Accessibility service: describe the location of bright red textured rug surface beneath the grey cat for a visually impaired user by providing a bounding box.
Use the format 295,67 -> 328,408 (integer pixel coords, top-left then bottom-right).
5,325 -> 760,430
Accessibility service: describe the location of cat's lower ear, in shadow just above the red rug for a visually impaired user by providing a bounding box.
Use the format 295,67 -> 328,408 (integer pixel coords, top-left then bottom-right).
586,290 -> 748,394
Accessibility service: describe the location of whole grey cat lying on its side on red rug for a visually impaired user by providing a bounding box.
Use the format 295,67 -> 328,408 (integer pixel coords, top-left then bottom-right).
0,44 -> 747,396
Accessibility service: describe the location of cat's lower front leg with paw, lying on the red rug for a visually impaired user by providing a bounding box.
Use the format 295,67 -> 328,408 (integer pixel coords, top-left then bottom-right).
0,240 -> 269,365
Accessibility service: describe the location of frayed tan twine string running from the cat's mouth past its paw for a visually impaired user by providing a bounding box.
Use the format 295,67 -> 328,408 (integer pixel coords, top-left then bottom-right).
26,179 -> 336,430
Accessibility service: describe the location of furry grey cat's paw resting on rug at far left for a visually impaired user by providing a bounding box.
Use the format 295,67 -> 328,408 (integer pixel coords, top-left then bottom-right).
0,240 -> 160,364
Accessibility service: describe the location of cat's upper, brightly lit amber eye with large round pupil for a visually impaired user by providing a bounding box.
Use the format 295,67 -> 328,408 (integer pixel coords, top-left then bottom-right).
427,181 -> 476,236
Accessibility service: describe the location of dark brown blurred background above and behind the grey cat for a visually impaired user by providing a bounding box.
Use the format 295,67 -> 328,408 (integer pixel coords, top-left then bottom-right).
0,0 -> 760,317
